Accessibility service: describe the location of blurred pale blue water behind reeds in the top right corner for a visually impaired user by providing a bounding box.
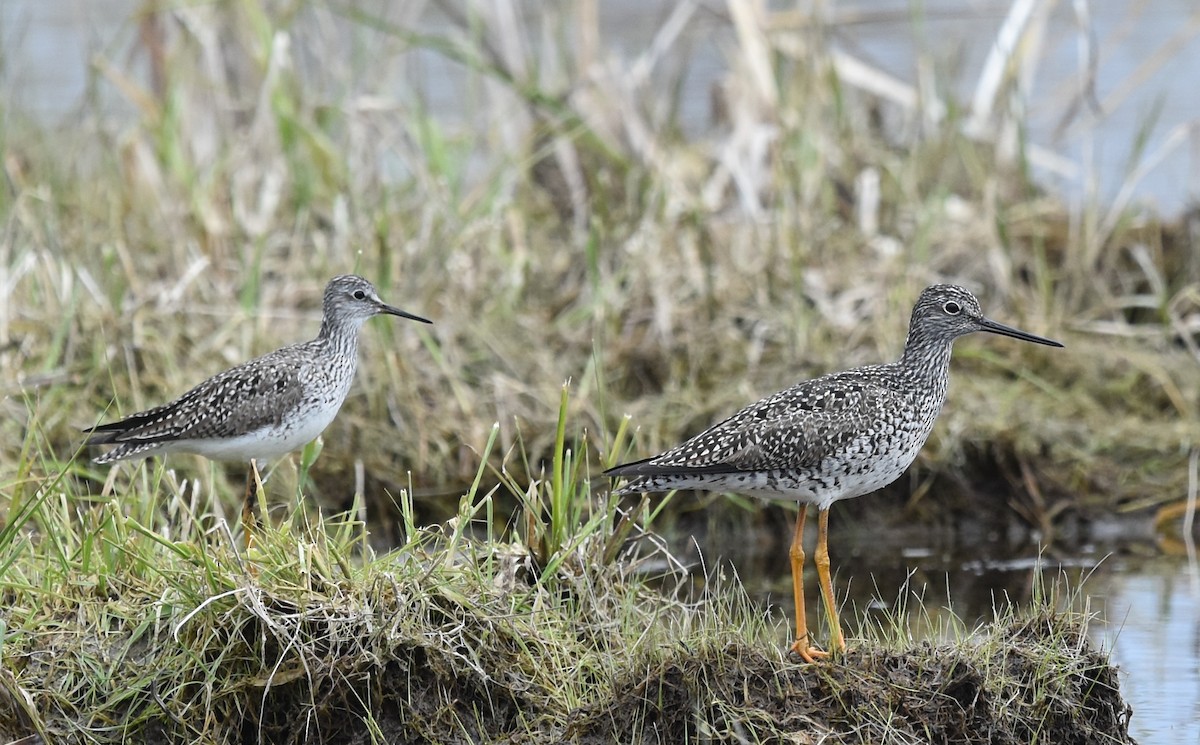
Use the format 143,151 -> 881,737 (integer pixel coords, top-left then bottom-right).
840,0 -> 1200,212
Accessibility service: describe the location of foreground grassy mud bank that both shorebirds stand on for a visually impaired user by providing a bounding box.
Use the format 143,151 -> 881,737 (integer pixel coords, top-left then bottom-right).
0,455 -> 1128,743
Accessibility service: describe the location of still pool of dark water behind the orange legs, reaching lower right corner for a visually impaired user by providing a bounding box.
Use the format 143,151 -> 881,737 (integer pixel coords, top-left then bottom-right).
670,506 -> 1200,745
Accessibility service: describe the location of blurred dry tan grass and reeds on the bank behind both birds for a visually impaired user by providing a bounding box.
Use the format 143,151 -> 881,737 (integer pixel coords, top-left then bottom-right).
0,4 -> 1200,527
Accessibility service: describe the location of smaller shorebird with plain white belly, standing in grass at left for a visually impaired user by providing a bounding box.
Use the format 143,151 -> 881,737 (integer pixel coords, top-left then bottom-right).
88,275 -> 431,543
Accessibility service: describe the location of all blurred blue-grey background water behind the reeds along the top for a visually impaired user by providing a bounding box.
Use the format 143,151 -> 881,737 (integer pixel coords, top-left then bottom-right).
7,0 -> 1200,212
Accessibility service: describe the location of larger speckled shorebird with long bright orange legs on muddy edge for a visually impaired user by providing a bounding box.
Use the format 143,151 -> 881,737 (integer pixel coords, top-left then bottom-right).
605,284 -> 1062,662
